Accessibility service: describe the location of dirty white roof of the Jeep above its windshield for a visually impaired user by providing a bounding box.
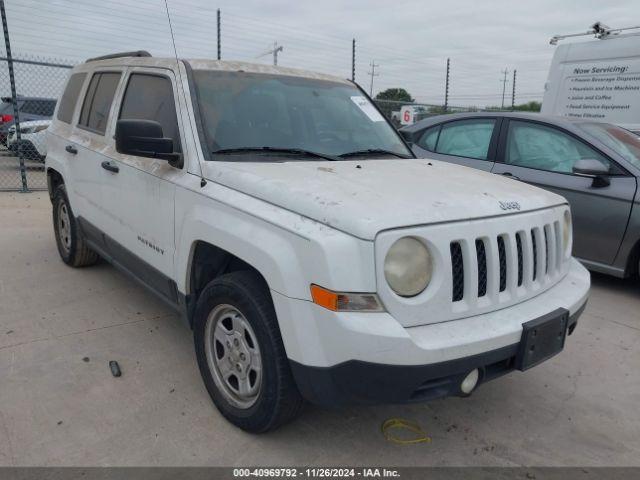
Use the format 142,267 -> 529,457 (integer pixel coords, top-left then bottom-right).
74,57 -> 351,84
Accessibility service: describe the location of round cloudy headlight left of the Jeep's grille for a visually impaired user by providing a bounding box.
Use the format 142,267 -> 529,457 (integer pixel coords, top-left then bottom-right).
384,237 -> 433,297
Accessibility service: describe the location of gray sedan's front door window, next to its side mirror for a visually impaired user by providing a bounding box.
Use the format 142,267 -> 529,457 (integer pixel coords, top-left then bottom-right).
505,120 -> 610,173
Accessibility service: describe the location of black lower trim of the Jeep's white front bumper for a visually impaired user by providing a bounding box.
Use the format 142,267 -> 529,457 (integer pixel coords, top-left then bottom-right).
290,306 -> 584,407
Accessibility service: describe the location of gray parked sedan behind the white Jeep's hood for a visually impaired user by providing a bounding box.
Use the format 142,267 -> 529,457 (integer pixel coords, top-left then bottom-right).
401,112 -> 640,277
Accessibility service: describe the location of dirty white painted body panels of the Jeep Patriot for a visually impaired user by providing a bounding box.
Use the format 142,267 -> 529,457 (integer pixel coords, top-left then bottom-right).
47,58 -> 589,376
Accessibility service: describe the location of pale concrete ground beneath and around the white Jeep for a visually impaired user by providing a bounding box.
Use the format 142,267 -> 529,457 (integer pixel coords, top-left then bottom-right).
0,192 -> 640,466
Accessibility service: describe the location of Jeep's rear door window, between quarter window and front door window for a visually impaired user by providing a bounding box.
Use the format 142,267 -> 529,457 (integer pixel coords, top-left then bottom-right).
78,72 -> 120,135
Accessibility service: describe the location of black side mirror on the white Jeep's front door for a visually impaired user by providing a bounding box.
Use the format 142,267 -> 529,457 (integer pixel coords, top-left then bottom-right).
115,119 -> 182,166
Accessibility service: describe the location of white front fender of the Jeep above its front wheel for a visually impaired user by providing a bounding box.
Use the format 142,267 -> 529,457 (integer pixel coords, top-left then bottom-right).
175,182 -> 376,300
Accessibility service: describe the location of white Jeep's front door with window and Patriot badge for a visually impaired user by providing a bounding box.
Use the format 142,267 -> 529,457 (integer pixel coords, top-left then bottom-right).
103,68 -> 186,302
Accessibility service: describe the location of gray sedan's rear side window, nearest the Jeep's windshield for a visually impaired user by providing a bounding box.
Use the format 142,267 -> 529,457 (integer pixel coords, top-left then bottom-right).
412,117 -> 501,172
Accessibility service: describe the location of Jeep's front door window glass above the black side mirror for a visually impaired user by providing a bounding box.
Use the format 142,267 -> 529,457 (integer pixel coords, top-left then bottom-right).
119,73 -> 181,152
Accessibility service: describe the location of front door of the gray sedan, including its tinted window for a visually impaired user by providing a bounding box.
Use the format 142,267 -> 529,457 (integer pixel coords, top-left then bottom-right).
493,119 -> 636,265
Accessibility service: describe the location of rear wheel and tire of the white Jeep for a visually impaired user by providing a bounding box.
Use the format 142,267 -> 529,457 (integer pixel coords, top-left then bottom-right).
53,185 -> 100,267
